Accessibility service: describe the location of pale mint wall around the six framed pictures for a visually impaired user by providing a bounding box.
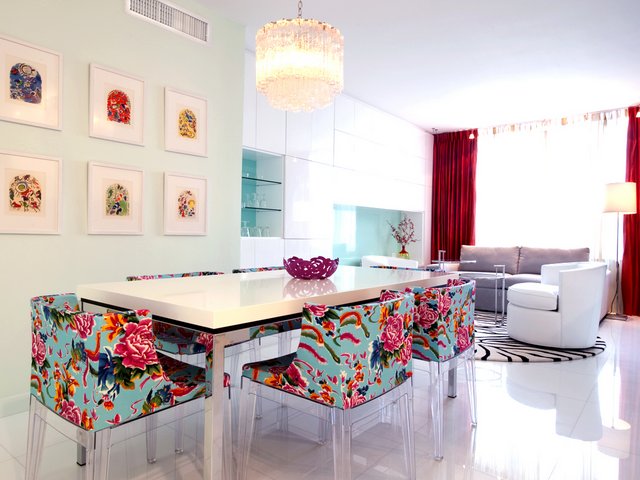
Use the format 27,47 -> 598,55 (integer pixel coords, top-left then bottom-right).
0,0 -> 244,417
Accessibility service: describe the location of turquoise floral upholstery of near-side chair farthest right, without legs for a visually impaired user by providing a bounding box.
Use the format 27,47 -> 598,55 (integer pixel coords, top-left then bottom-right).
400,280 -> 476,362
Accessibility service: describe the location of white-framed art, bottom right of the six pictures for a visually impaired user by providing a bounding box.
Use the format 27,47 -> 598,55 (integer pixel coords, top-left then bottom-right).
164,172 -> 207,235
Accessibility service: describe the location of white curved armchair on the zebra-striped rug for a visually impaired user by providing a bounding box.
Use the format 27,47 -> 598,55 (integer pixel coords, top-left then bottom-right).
507,262 -> 607,348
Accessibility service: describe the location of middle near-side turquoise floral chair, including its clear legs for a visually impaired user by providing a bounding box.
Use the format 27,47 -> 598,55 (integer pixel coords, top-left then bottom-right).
238,292 -> 415,479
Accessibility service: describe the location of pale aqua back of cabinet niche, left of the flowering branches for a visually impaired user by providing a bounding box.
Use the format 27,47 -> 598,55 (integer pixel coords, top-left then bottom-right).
333,205 -> 402,265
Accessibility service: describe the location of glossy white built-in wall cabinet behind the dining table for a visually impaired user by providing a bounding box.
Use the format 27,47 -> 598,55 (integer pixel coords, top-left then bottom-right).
241,52 -> 432,267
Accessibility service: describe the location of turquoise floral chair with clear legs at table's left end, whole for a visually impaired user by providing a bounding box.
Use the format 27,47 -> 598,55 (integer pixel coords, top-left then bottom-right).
26,294 -> 230,479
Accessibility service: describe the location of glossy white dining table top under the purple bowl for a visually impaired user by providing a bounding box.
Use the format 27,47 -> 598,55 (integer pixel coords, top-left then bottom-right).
77,266 -> 457,331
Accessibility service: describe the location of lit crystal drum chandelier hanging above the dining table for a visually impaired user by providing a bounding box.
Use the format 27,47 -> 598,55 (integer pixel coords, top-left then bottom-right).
256,1 -> 344,112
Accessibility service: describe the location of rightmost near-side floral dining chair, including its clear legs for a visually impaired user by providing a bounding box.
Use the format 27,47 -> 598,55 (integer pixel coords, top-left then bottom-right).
400,280 -> 477,459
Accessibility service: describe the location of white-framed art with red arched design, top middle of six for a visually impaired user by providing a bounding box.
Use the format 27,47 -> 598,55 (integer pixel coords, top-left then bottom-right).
89,64 -> 144,145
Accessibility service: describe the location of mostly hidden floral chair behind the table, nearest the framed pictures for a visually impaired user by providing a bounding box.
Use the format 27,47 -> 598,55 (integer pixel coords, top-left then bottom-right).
127,271 -> 223,361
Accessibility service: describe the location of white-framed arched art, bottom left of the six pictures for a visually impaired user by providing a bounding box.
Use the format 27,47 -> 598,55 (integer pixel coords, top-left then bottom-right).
0,152 -> 62,234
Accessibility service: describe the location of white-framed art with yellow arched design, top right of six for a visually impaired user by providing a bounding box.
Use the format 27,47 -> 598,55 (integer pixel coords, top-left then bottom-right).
164,87 -> 207,157
